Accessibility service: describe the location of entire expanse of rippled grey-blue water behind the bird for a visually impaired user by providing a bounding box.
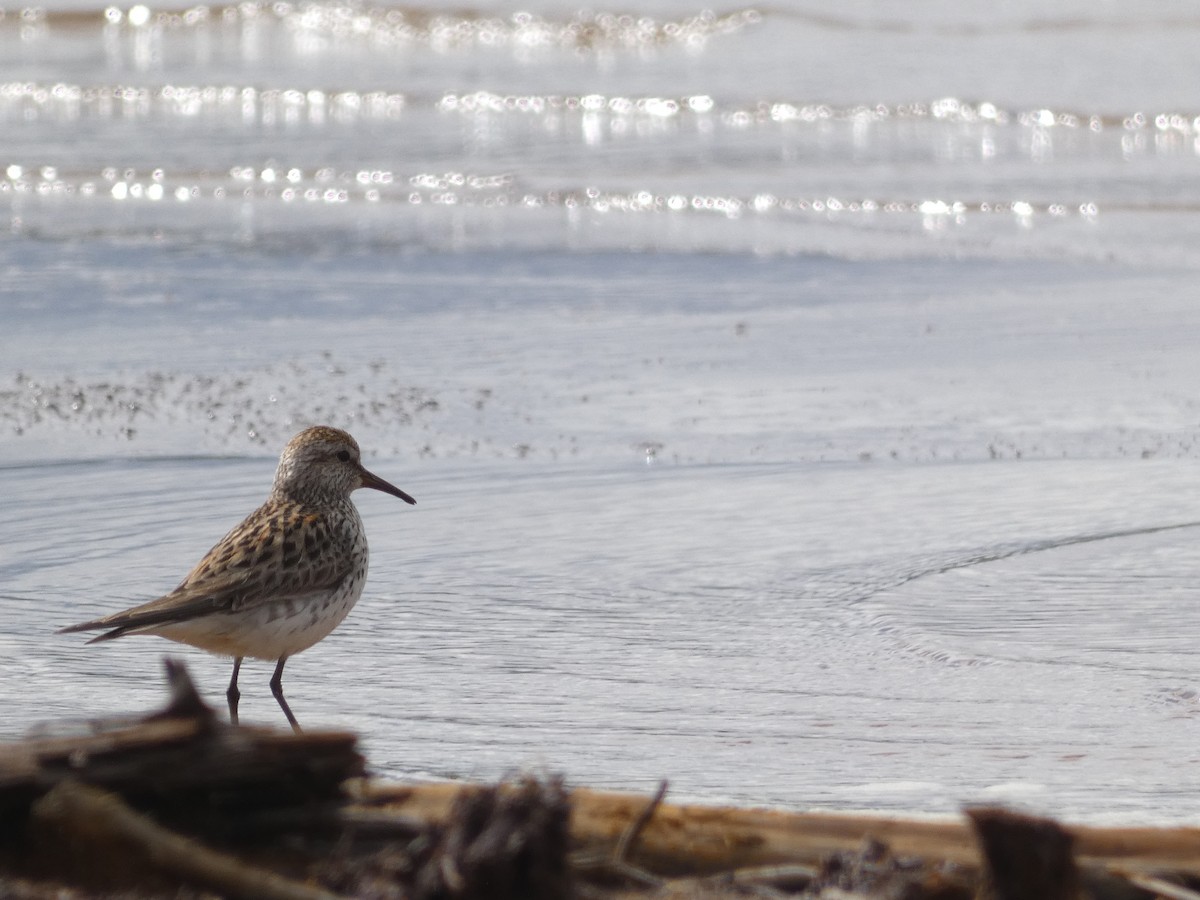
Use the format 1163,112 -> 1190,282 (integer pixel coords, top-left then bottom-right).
0,0 -> 1200,822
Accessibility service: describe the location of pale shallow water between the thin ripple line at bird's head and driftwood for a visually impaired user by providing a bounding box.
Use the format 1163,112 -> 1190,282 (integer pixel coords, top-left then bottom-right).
4,460 -> 1200,818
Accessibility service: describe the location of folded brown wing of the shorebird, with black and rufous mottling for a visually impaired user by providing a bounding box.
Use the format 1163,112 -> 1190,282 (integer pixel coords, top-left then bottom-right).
62,503 -> 353,641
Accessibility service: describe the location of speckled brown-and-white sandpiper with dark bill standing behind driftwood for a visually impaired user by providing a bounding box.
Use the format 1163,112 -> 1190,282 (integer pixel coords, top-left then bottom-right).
59,425 -> 416,732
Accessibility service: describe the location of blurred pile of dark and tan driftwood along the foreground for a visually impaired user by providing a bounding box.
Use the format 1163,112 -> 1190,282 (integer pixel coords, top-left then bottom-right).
0,664 -> 1200,900
